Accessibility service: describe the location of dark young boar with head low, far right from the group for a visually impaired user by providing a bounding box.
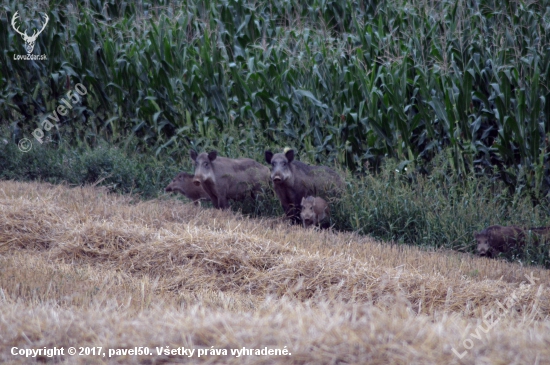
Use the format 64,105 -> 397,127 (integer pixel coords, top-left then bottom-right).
474,225 -> 525,257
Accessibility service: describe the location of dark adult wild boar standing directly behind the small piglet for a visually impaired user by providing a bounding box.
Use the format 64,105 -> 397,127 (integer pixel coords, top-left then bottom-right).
265,149 -> 344,222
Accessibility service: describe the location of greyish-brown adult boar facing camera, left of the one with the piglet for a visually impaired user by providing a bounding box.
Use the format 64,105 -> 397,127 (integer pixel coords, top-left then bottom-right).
190,150 -> 269,209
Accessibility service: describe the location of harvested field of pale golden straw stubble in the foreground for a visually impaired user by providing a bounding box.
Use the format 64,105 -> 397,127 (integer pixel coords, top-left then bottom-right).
0,181 -> 550,364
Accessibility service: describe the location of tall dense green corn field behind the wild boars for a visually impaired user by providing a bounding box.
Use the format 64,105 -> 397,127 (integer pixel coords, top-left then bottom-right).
0,0 -> 550,202
